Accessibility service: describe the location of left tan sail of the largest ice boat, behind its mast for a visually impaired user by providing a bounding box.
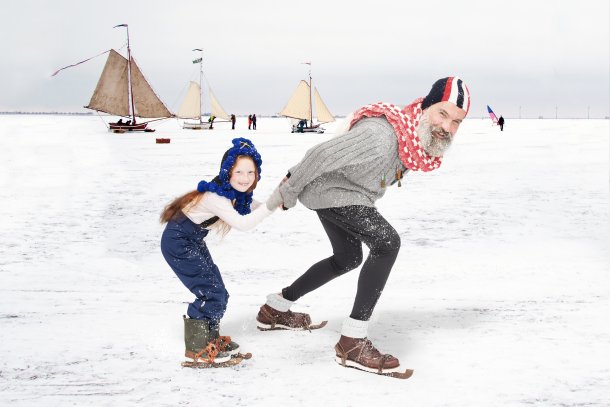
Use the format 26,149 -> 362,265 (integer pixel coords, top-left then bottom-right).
85,49 -> 129,116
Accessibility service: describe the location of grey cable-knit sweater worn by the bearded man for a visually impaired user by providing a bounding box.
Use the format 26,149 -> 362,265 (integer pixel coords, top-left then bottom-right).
280,117 -> 405,209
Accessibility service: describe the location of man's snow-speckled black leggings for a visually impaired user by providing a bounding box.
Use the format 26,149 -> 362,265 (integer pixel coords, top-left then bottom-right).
282,205 -> 400,321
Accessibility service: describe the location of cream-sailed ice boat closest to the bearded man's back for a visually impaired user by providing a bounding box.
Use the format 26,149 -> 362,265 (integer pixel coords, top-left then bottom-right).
280,62 -> 335,133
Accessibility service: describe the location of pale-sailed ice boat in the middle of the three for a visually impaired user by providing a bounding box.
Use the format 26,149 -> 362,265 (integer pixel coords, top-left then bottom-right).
176,48 -> 231,130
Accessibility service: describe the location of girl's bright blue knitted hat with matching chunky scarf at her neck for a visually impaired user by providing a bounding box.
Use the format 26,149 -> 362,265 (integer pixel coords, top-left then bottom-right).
197,137 -> 263,215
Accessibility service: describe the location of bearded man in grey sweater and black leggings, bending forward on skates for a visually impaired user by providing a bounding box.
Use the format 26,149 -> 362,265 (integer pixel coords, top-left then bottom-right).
256,77 -> 470,375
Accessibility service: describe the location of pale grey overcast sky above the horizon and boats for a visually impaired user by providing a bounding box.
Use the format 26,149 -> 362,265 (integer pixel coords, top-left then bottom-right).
0,0 -> 610,117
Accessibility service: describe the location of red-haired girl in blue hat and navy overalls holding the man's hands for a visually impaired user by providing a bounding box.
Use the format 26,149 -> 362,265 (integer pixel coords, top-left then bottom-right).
161,138 -> 282,363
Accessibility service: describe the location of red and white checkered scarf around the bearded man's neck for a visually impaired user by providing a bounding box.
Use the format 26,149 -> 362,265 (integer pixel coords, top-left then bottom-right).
349,98 -> 442,172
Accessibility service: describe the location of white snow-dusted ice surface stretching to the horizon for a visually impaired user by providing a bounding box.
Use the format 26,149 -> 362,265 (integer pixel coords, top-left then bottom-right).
0,116 -> 610,407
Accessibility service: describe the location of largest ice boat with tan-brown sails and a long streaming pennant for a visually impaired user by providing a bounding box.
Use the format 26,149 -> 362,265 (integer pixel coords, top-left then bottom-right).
53,24 -> 174,133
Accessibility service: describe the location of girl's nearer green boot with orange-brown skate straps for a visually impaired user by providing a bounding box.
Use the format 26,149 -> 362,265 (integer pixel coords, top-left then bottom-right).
182,315 -> 231,363
